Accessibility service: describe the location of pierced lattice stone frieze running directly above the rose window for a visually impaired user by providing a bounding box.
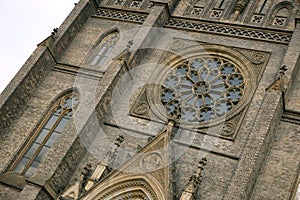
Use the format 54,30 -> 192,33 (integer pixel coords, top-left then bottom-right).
166,19 -> 292,43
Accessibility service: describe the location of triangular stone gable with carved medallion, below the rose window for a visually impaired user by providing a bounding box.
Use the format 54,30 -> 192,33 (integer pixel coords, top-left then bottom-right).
81,121 -> 175,200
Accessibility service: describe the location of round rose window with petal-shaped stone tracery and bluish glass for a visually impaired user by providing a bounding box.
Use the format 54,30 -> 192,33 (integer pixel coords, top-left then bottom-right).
160,57 -> 245,122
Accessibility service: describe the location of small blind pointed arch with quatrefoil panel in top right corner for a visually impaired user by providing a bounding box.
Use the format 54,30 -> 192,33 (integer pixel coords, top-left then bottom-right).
268,1 -> 294,27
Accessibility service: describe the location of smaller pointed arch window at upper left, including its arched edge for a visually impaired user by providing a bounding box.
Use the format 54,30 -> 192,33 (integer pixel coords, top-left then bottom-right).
86,28 -> 120,67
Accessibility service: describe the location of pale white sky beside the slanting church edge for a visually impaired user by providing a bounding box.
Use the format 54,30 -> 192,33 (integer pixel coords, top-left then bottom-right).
0,0 -> 78,92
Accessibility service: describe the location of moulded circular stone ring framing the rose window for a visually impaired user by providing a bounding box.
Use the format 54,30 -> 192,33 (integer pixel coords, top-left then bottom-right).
146,45 -> 256,128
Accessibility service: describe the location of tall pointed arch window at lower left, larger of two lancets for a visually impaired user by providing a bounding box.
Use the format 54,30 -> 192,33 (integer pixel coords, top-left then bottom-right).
13,93 -> 79,177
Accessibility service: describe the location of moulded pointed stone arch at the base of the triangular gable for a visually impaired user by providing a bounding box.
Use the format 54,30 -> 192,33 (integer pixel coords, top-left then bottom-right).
82,175 -> 166,200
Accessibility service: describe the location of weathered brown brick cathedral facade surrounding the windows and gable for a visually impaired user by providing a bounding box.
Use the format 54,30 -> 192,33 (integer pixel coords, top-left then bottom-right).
0,0 -> 300,200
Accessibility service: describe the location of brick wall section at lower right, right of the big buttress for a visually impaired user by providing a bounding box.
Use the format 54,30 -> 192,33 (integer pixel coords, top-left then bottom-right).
251,122 -> 300,199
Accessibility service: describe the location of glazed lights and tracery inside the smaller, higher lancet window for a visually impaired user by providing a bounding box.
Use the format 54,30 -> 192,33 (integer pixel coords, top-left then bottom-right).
88,32 -> 119,66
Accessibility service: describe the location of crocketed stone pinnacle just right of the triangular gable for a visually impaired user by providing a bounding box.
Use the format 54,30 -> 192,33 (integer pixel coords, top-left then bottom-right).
180,157 -> 207,200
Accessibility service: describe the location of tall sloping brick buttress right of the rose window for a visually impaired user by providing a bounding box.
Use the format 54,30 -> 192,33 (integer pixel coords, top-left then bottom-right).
224,90 -> 282,200
